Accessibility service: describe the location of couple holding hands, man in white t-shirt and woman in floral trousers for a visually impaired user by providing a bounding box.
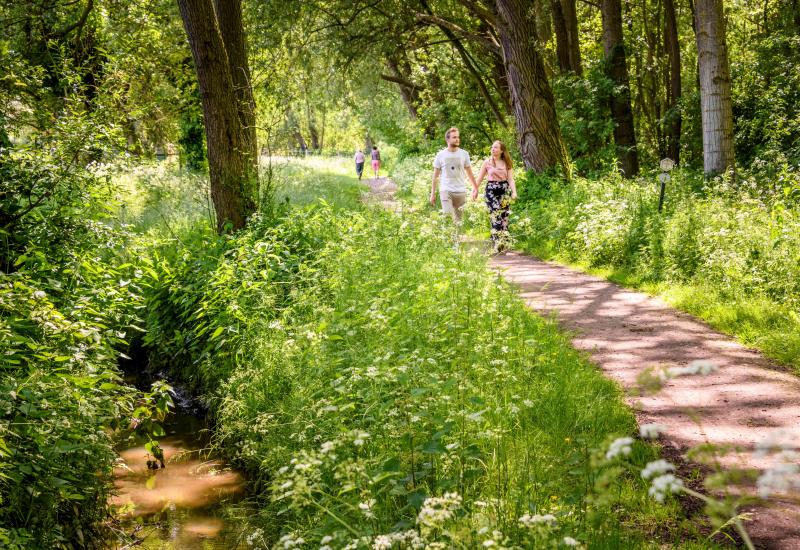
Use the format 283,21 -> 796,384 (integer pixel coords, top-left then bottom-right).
430,128 -> 517,253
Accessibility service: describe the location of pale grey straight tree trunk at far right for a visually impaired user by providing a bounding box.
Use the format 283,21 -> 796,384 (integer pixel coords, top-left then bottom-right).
696,0 -> 734,175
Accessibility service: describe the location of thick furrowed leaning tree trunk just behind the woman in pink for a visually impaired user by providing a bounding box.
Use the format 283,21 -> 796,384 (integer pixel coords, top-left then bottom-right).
495,0 -> 571,177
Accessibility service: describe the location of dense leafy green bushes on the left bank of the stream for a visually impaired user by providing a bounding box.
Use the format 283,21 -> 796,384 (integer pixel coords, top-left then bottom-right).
0,116 -> 169,548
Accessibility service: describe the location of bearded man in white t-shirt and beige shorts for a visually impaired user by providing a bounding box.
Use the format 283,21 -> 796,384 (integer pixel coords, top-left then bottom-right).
431,128 -> 478,222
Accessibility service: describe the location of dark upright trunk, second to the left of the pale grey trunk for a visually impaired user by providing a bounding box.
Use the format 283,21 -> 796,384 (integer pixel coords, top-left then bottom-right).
600,0 -> 639,178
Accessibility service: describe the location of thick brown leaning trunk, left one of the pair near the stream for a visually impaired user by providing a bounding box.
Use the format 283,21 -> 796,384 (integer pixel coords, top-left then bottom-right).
178,0 -> 256,232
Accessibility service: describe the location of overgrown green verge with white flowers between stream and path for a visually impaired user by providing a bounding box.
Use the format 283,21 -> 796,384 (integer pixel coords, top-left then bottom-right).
148,158 -> 724,548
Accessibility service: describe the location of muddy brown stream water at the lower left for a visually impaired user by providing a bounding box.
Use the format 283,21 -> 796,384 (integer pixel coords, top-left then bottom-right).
112,412 -> 246,550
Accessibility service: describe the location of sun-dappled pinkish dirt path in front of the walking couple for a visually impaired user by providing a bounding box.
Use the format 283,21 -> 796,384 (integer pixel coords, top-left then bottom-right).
492,253 -> 800,549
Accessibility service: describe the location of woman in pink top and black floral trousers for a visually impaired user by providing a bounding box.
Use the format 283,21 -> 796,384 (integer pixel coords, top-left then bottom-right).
478,140 -> 517,254
